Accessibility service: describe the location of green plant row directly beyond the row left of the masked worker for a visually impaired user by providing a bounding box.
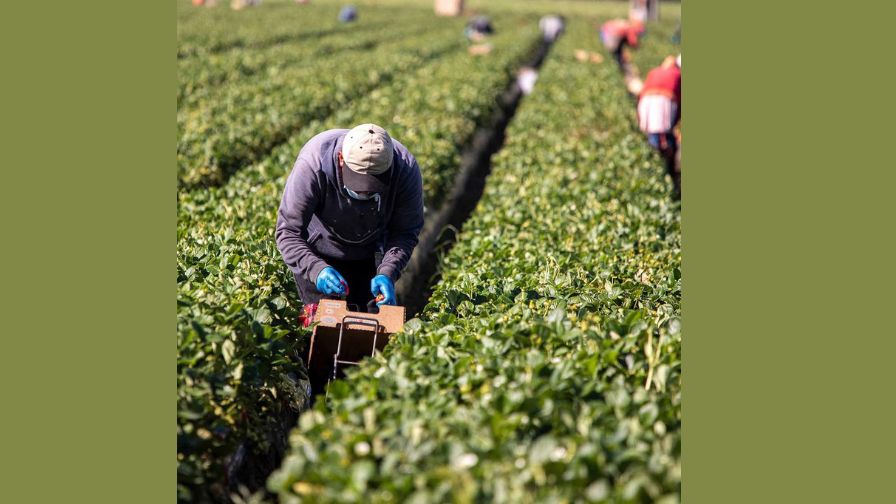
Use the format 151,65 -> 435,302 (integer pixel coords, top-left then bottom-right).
177,24 -> 461,186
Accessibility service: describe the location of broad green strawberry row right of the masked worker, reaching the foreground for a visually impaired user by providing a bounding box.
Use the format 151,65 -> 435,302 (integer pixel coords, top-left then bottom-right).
269,18 -> 681,503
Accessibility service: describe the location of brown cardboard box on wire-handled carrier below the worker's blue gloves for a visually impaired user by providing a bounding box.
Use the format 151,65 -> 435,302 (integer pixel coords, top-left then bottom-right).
307,299 -> 405,394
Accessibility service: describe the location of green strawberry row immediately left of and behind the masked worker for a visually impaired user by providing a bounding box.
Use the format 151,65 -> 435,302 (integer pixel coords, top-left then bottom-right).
178,19 -> 537,504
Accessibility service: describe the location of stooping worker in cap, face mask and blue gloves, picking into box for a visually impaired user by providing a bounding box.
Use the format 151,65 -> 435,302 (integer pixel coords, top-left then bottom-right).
275,124 -> 423,325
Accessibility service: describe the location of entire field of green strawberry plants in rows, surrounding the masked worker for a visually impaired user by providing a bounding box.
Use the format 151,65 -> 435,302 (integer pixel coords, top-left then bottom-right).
177,0 -> 681,502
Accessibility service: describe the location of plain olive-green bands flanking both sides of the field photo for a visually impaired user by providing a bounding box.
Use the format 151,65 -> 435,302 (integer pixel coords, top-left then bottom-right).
0,0 -> 894,503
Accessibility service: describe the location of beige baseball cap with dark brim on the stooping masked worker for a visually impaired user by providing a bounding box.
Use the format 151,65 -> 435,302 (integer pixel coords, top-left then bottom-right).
342,123 -> 394,192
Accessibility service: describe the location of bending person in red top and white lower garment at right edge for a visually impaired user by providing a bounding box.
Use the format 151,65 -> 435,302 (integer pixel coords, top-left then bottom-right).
638,55 -> 681,191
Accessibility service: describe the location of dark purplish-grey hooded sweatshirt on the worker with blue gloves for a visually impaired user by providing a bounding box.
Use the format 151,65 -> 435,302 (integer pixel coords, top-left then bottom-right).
275,129 -> 423,284
